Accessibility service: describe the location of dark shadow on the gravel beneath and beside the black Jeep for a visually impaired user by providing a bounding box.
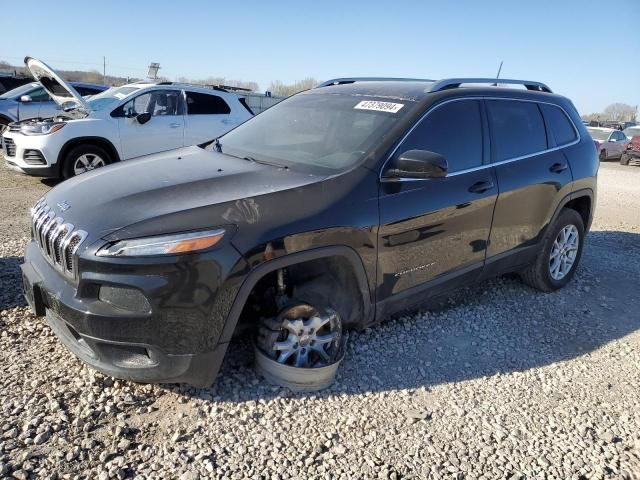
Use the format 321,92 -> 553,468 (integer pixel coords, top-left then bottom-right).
171,231 -> 640,402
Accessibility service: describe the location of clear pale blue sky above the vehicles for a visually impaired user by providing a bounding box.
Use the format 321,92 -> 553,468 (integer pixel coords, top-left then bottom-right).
0,0 -> 640,114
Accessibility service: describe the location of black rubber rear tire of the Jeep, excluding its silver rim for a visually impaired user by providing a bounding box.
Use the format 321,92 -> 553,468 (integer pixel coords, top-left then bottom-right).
520,208 -> 584,292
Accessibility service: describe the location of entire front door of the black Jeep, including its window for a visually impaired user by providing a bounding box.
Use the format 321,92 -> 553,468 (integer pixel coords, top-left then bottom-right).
377,99 -> 498,301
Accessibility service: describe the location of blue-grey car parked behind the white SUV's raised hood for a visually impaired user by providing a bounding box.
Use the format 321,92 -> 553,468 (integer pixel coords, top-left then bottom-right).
0,82 -> 108,125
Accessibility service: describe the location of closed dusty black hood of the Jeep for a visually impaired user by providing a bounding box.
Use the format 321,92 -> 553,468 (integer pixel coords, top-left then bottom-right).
45,146 -> 326,245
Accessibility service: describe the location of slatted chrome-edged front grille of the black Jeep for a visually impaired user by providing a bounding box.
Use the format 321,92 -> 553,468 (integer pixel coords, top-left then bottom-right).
31,199 -> 87,279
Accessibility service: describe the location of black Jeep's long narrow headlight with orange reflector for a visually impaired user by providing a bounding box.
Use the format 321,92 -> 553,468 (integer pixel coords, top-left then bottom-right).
96,228 -> 224,257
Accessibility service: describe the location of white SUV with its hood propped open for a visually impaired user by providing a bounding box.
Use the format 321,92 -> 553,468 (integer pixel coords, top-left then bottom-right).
2,57 -> 252,178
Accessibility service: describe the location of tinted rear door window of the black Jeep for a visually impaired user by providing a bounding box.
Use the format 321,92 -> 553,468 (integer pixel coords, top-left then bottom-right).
487,100 -> 547,162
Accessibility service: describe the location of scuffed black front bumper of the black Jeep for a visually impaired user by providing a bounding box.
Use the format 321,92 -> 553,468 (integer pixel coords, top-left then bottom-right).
22,241 -> 248,387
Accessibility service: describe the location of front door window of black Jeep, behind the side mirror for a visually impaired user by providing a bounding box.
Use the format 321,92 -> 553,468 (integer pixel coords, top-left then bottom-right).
398,100 -> 482,172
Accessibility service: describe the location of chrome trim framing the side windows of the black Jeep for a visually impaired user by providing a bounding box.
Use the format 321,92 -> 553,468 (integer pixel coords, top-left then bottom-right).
379,96 -> 582,182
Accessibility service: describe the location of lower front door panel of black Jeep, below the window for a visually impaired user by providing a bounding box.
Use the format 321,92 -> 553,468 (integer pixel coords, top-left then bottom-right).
378,171 -> 498,300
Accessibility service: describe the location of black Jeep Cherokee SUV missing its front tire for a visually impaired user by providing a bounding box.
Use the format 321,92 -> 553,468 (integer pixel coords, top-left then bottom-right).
22,78 -> 598,386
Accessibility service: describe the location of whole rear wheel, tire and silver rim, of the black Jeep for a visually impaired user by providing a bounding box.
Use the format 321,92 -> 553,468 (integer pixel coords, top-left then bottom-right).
521,209 -> 584,292
